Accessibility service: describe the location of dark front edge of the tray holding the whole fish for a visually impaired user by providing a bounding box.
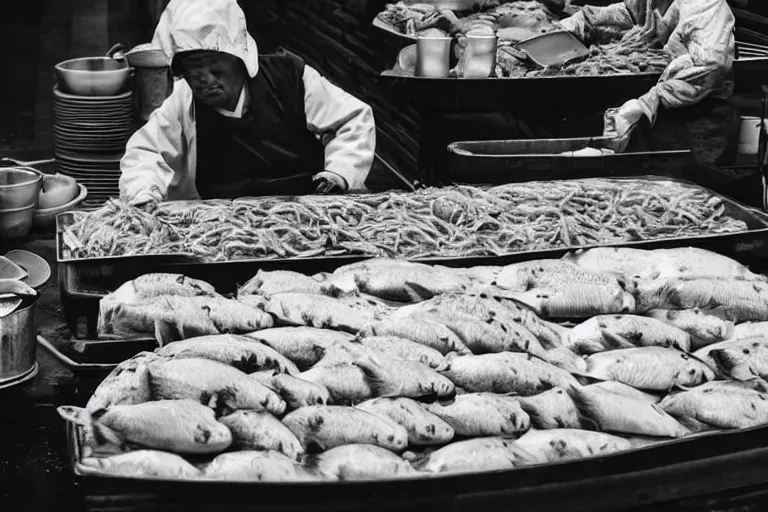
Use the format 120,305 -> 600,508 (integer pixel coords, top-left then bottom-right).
66,404 -> 768,512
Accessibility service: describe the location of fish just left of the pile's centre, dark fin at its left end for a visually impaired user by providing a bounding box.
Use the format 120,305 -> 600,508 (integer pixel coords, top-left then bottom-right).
354,354 -> 456,400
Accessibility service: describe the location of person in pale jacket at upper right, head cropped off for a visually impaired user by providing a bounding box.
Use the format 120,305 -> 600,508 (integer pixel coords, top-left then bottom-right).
561,0 -> 739,186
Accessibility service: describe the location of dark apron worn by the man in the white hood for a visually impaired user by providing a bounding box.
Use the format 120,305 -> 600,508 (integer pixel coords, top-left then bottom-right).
195,58 -> 325,199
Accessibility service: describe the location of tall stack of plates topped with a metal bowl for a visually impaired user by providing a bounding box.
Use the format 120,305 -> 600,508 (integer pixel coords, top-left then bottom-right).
53,57 -> 133,206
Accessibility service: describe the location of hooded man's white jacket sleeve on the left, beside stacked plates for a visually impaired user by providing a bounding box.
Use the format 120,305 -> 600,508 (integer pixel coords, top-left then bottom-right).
120,80 -> 192,205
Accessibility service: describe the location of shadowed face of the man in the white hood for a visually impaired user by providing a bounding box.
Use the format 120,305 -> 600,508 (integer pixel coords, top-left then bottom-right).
181,51 -> 245,110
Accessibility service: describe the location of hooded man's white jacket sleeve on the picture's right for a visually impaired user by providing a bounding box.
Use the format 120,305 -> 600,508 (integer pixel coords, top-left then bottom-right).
303,65 -> 376,190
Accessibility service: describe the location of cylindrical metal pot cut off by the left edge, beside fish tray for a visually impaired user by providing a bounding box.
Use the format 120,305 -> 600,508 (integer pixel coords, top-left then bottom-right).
0,297 -> 38,388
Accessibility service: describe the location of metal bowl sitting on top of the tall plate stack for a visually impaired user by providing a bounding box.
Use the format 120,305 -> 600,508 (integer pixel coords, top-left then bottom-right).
55,57 -> 131,96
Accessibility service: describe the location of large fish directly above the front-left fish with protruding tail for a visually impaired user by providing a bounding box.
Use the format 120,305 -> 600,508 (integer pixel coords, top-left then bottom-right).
148,358 -> 286,415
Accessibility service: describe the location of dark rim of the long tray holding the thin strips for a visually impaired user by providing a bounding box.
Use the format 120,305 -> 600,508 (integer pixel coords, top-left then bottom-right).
57,176 -> 768,340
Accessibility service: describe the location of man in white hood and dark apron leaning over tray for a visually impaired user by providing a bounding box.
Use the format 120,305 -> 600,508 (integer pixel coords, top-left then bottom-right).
120,0 -> 376,208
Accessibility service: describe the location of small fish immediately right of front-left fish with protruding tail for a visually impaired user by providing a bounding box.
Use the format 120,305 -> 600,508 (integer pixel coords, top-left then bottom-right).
219,411 -> 304,461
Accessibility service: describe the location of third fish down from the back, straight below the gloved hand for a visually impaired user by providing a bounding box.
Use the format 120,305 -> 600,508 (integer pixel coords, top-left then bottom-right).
566,315 -> 691,355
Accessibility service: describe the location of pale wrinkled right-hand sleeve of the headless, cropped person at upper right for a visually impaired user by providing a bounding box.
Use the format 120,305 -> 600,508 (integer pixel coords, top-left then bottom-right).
640,0 -> 736,124
